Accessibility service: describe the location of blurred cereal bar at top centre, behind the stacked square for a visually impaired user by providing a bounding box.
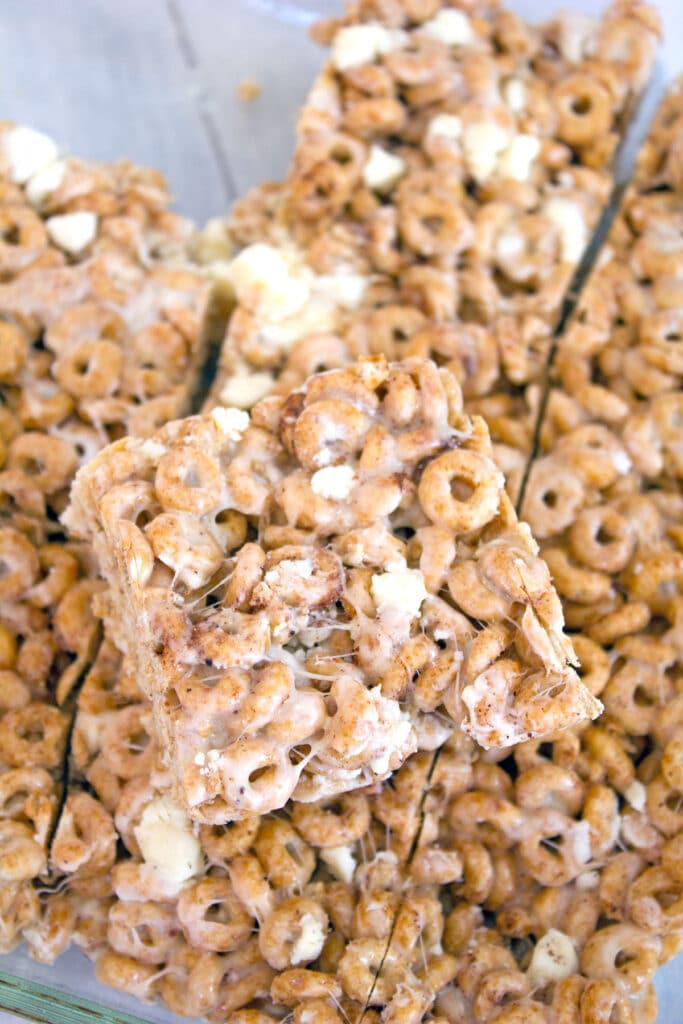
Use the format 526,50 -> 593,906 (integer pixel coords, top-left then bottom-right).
208,0 -> 658,430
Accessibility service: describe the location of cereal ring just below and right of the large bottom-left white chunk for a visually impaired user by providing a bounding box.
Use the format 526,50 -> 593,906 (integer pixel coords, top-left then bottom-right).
178,877 -> 254,953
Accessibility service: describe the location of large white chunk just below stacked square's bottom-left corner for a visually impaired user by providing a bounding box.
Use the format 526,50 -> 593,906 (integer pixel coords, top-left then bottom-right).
134,797 -> 203,887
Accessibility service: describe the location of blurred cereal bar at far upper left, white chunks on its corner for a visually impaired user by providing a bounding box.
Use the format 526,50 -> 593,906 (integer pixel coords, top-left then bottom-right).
0,124 -> 216,532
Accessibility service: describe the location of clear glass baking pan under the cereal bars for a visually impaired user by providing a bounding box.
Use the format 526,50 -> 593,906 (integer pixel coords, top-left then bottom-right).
0,0 -> 683,1024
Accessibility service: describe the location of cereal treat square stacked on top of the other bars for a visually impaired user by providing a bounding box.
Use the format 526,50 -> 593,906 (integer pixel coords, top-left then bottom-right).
65,358 -> 601,821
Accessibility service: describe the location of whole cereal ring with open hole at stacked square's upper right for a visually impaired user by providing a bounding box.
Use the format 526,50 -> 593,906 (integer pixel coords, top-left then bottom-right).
418,449 -> 502,534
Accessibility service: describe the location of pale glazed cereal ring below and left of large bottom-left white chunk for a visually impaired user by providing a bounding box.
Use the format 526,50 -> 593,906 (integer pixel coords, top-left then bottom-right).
106,901 -> 179,964
